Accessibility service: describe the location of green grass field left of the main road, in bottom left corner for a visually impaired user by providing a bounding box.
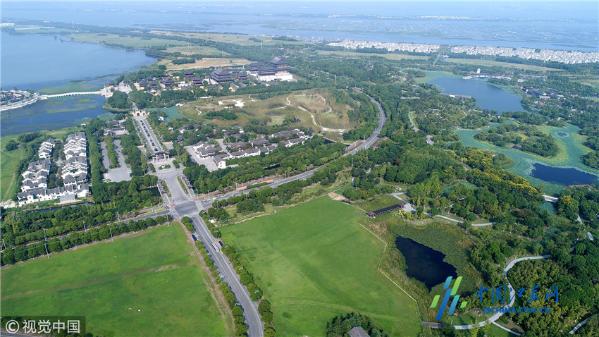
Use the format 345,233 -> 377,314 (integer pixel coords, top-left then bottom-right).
1,224 -> 229,337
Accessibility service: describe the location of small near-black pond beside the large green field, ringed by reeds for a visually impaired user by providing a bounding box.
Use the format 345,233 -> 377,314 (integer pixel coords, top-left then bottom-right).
395,236 -> 457,289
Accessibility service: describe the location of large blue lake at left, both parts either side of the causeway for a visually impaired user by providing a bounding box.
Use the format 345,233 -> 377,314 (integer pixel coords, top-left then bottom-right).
0,32 -> 154,135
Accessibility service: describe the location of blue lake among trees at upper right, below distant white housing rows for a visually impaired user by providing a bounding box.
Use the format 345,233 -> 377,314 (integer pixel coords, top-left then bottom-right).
429,76 -> 524,113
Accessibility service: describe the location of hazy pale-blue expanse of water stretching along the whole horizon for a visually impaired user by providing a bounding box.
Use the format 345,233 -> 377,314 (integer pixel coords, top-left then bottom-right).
2,1 -> 599,51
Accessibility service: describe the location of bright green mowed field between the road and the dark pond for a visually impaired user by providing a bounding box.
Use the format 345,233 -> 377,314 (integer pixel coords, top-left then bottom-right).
222,197 -> 420,337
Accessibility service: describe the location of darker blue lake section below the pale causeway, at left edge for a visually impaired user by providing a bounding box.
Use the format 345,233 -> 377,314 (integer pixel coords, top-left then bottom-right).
0,95 -> 109,136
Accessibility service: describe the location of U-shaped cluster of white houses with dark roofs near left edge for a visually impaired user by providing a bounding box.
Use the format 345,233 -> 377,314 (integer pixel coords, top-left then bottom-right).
17,132 -> 89,205
